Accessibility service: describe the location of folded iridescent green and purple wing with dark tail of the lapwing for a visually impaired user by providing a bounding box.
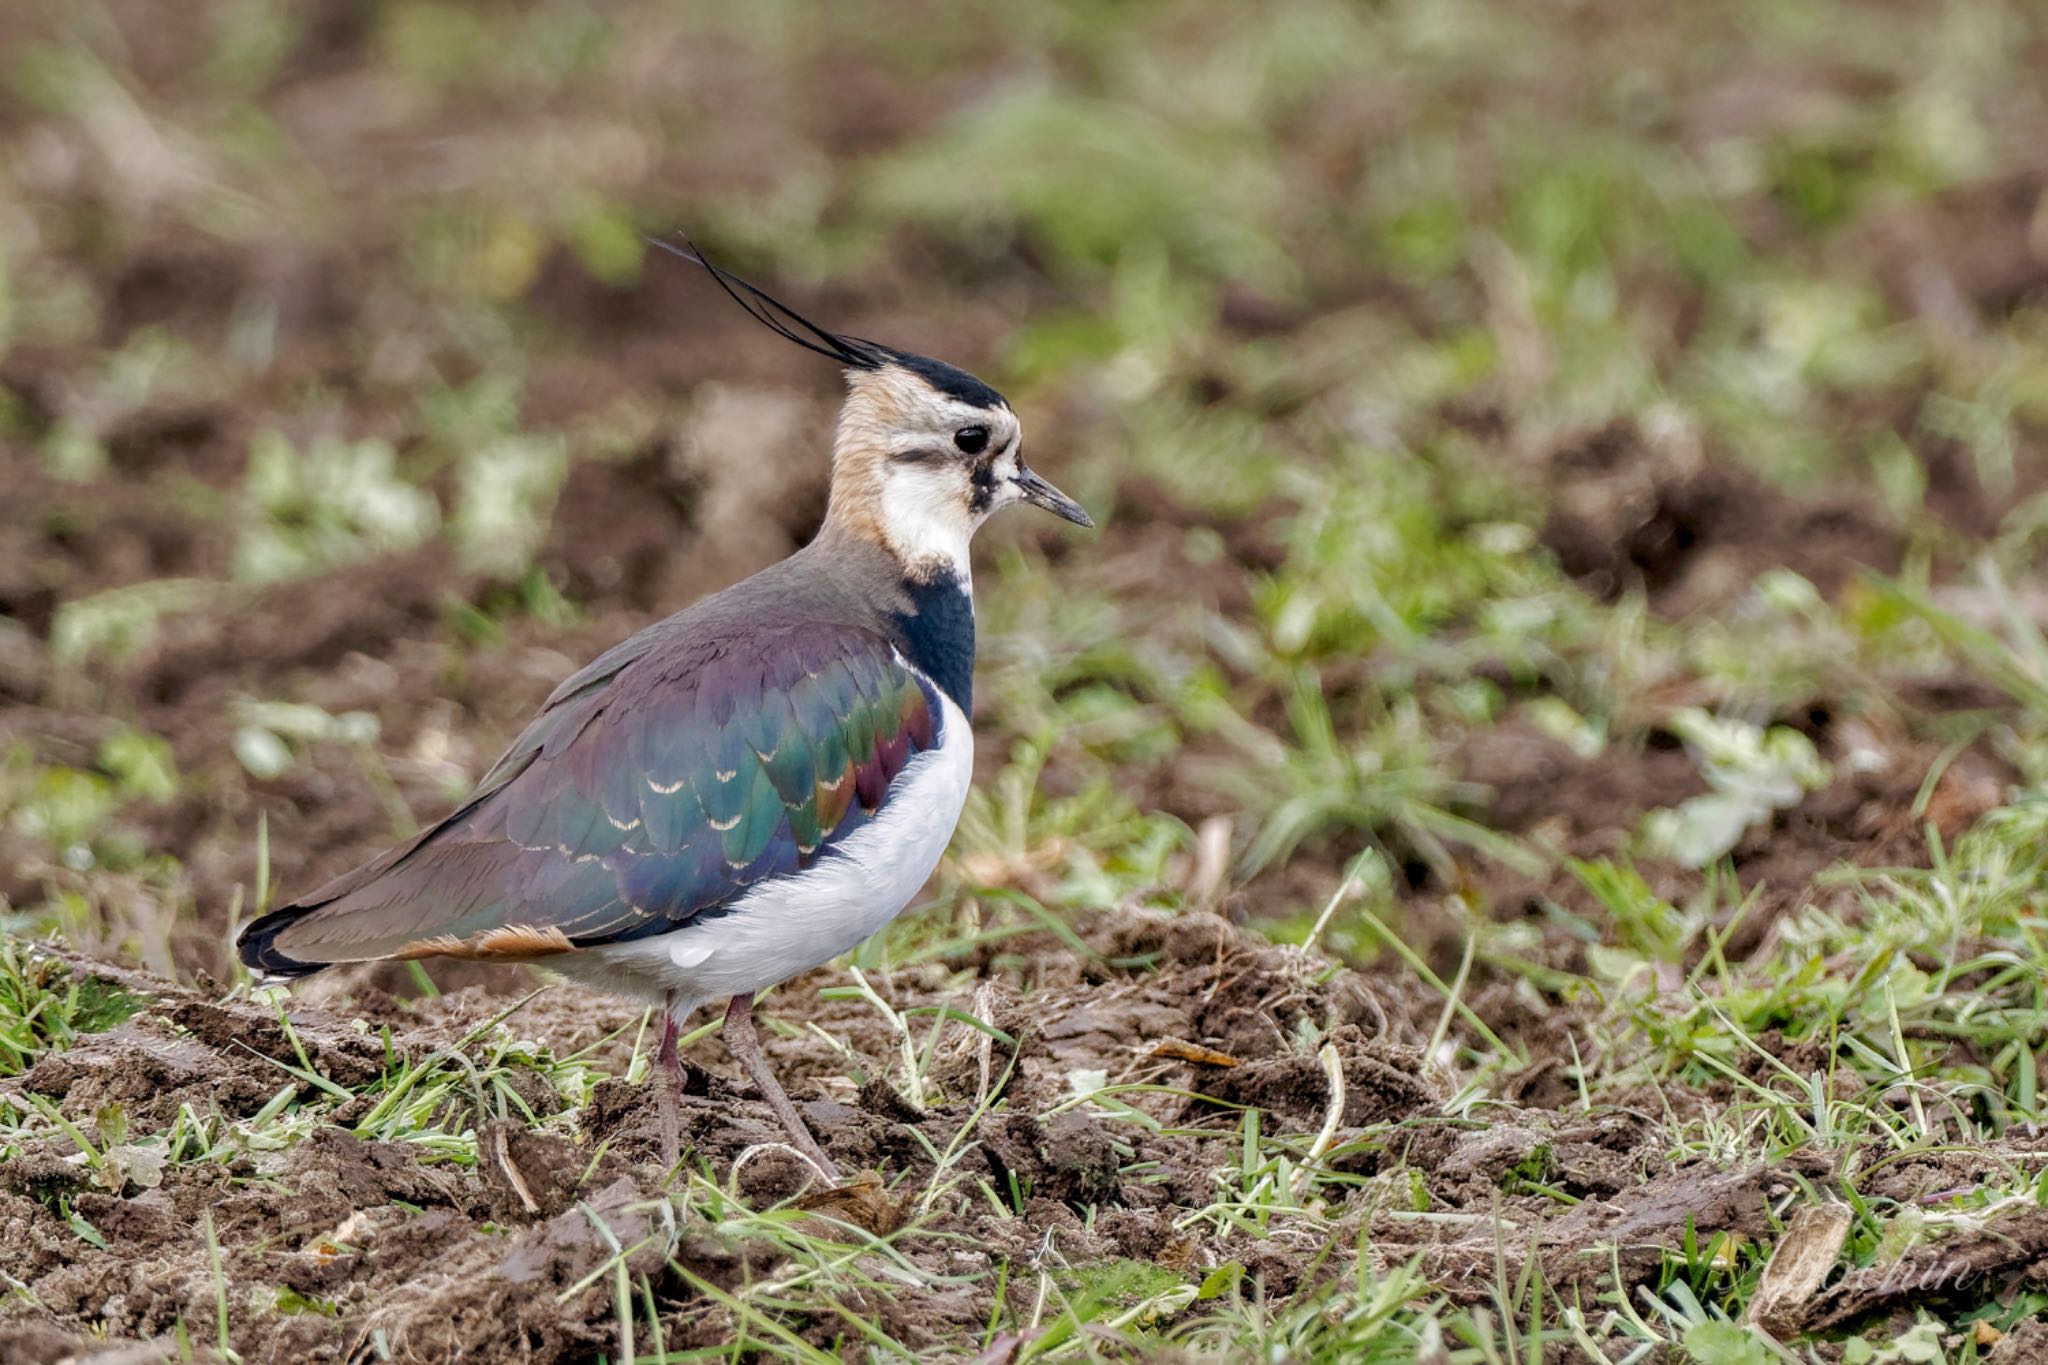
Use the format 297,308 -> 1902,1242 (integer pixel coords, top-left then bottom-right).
242,624 -> 942,974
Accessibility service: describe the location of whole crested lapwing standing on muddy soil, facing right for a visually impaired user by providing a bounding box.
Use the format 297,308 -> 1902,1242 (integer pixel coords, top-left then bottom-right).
236,237 -> 1094,1183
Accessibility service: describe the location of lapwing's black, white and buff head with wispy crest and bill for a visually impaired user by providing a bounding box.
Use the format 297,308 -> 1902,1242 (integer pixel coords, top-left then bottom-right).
655,241 -> 1094,583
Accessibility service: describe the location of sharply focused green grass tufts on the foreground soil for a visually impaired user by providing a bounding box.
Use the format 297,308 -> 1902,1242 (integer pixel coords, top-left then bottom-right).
12,789 -> 2048,1361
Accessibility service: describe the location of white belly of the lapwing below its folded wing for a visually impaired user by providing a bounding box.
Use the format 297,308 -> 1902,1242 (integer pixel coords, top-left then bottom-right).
565,692 -> 975,1013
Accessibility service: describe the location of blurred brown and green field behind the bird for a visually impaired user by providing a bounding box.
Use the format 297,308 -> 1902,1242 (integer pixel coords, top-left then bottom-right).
0,0 -> 2048,970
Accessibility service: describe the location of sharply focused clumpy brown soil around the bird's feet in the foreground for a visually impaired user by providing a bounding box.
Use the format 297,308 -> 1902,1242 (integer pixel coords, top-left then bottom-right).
0,913 -> 1982,1361
